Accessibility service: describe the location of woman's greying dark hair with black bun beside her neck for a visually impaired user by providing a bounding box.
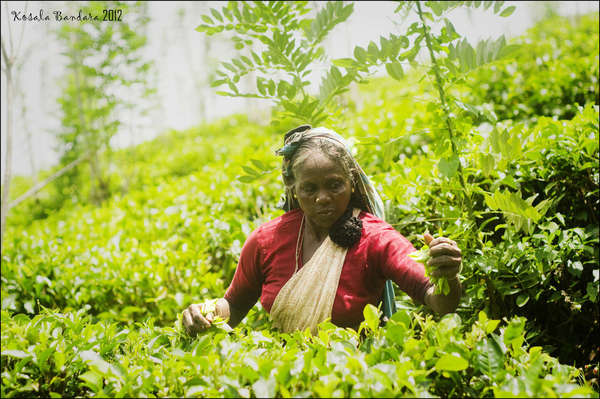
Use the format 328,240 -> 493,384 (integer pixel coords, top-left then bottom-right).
281,133 -> 360,248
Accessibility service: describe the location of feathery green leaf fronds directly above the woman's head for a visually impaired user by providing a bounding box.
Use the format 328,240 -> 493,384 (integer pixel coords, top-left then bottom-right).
196,1 -> 355,125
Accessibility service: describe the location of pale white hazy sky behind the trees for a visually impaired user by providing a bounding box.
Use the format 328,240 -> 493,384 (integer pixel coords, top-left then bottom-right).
0,1 -> 598,176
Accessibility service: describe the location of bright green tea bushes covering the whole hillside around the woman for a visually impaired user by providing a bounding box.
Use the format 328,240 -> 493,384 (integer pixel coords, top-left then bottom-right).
1,10 -> 599,397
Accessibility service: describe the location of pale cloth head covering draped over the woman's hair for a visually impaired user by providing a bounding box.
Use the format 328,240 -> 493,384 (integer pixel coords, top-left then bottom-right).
275,125 -> 385,219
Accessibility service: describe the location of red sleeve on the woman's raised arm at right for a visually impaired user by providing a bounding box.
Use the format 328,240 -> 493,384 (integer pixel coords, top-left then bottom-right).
369,227 -> 431,304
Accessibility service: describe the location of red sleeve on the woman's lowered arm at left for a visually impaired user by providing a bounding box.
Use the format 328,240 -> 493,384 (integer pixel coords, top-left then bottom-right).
225,227 -> 264,314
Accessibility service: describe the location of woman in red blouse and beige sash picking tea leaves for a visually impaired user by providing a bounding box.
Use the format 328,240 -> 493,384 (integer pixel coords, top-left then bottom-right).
182,125 -> 461,335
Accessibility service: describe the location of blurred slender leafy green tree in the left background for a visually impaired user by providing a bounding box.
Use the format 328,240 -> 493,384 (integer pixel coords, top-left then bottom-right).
56,2 -> 152,203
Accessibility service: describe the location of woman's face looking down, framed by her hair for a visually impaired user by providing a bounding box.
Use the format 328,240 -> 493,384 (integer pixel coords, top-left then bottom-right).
294,151 -> 352,230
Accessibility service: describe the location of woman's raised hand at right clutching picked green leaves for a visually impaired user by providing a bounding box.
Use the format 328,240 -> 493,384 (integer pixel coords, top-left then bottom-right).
423,233 -> 462,280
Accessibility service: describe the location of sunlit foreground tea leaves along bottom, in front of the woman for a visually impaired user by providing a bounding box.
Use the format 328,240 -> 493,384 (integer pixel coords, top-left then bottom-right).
2,307 -> 593,397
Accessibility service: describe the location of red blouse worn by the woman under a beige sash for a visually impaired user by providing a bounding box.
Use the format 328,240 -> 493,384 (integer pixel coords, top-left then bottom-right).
225,209 -> 431,327
